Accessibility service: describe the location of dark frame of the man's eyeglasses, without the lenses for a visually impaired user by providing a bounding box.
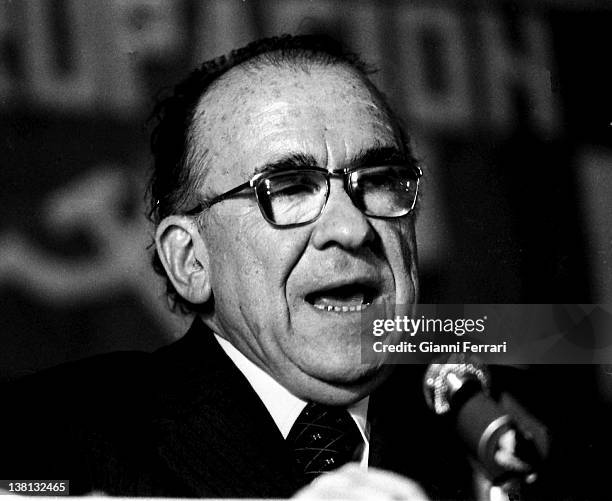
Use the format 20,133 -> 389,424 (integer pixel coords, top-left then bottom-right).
185,164 -> 423,228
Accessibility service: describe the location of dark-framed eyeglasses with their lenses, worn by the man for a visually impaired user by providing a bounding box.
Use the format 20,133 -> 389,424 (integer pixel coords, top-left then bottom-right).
187,165 -> 423,227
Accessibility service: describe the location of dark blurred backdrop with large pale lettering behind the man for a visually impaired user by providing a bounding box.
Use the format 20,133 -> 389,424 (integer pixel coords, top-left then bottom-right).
0,0 -> 612,396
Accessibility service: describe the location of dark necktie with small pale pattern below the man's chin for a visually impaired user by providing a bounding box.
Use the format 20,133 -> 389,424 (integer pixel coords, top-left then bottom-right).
287,403 -> 363,483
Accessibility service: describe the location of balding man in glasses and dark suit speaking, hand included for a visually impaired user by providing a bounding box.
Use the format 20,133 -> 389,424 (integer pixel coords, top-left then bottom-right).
0,36 -> 588,499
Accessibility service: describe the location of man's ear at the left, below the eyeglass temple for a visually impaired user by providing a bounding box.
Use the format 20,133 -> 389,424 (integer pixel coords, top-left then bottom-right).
155,216 -> 211,304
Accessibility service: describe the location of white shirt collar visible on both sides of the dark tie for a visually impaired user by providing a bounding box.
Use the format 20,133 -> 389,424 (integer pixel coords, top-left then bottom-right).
215,334 -> 370,468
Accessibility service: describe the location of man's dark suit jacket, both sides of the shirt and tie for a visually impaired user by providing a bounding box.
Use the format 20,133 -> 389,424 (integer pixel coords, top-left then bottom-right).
0,321 -> 608,499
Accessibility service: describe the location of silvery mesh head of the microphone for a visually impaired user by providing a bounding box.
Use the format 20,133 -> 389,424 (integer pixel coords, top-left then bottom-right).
423,353 -> 491,415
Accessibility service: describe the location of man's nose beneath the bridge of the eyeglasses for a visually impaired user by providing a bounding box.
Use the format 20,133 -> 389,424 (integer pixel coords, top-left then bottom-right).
312,178 -> 375,250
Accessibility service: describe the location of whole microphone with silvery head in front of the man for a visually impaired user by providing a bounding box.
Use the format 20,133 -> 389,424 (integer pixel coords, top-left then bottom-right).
423,354 -> 542,485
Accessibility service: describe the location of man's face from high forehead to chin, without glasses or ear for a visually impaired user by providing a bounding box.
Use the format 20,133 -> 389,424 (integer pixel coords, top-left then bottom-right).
194,66 -> 417,404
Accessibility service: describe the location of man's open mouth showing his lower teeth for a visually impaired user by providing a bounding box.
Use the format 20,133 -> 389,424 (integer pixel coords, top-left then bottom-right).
304,283 -> 378,313
